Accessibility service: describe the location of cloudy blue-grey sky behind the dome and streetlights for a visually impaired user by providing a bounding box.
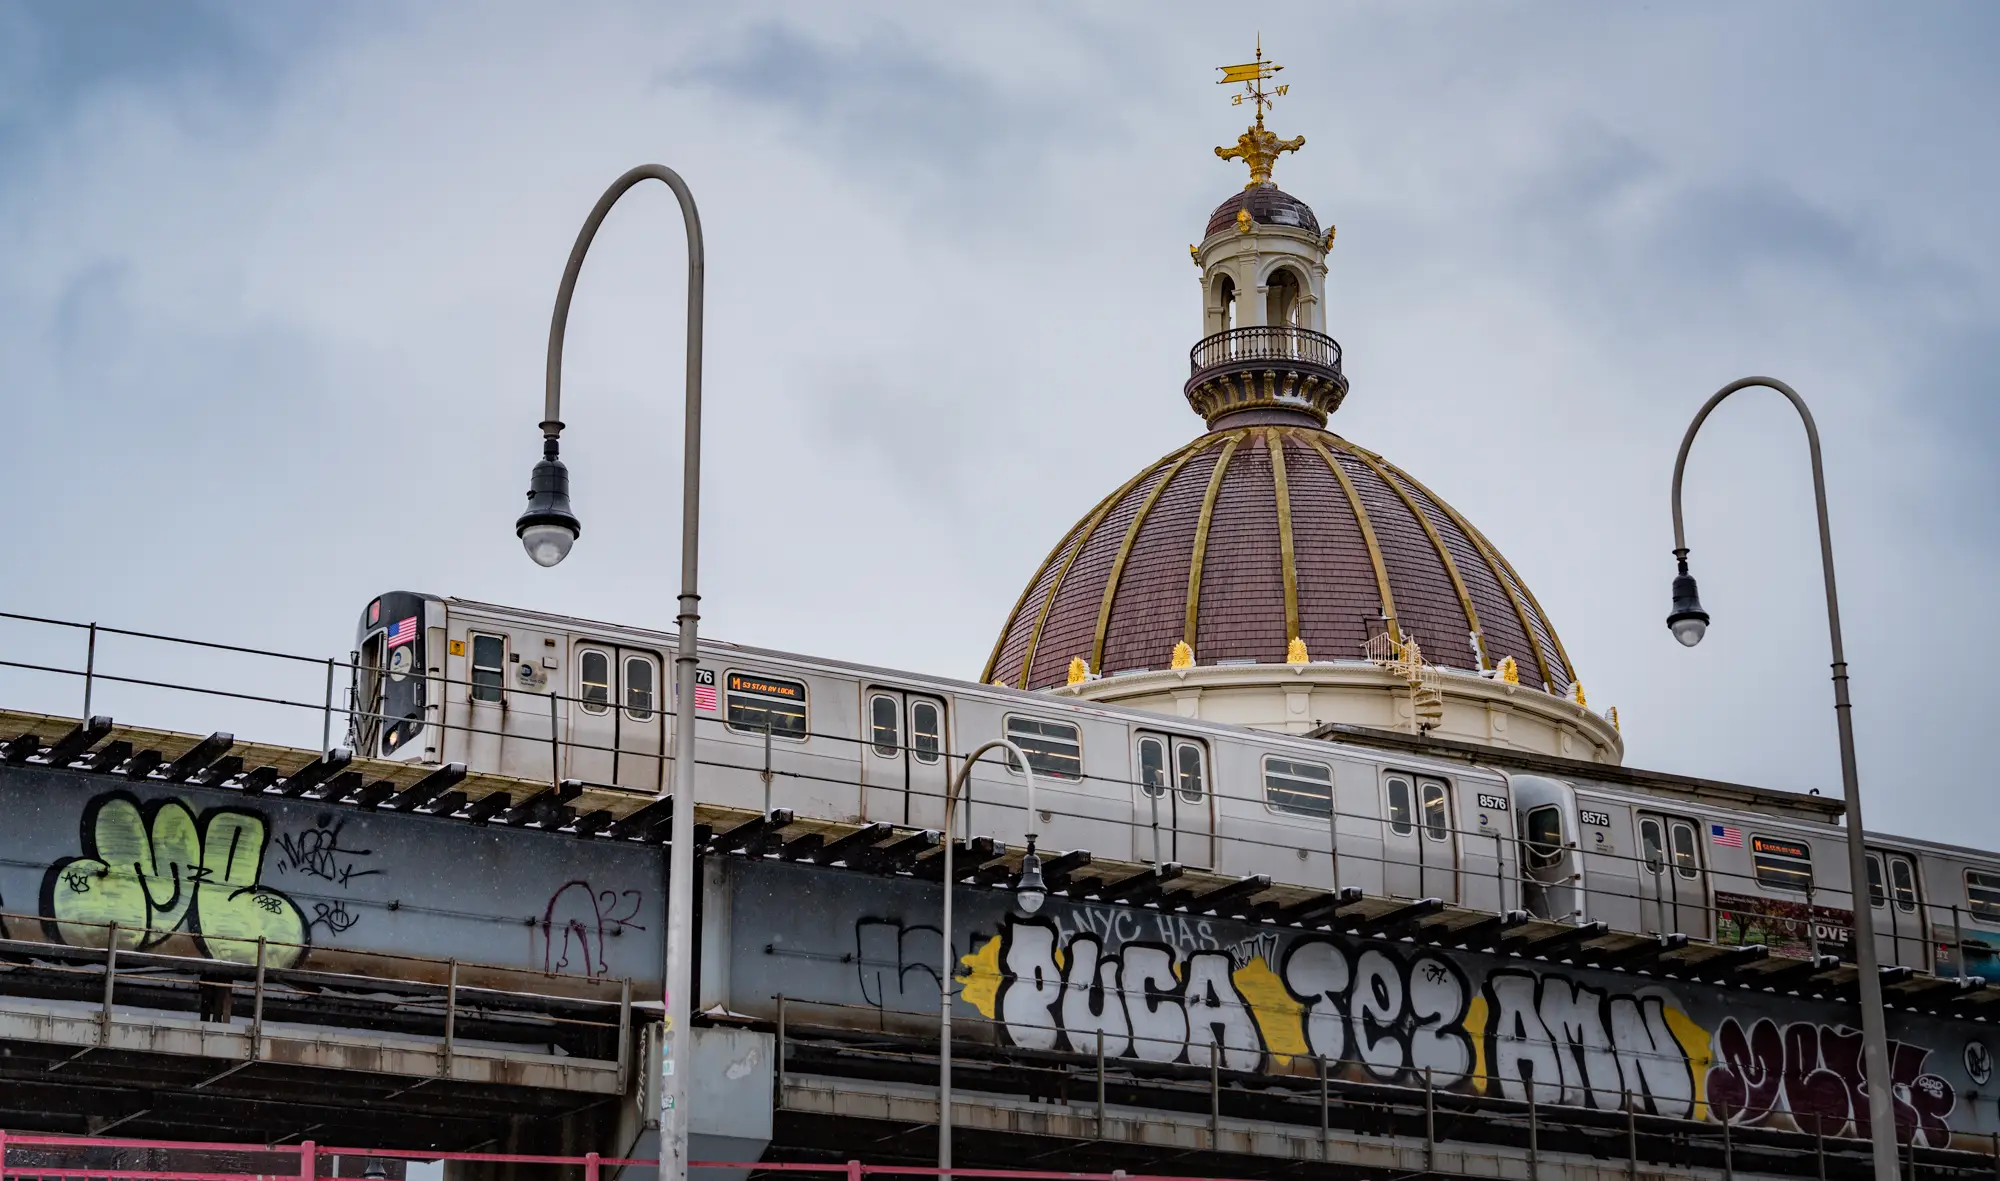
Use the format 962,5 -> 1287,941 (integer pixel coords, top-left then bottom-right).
0,0 -> 2000,849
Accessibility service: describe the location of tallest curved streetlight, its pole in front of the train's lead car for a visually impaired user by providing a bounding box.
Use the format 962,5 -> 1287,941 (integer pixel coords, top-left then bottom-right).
514,164 -> 704,1181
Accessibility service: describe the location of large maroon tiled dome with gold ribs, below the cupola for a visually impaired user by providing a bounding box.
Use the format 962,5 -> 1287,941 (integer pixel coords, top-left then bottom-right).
982,422 -> 1576,695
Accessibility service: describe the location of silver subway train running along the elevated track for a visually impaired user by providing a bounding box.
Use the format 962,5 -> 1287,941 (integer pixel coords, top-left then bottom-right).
350,593 -> 2000,979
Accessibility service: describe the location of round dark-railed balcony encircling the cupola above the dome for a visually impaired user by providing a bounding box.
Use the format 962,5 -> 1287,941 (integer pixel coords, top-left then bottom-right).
1186,324 -> 1348,426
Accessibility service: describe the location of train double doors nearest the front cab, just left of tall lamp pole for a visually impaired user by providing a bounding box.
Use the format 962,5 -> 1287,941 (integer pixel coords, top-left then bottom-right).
560,641 -> 666,791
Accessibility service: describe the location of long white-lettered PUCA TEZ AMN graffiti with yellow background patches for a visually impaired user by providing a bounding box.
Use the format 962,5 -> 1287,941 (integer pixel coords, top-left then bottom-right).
956,919 -> 1710,1117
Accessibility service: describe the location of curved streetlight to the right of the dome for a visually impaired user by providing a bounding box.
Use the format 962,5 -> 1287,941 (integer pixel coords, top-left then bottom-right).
1666,376 -> 1898,1181
